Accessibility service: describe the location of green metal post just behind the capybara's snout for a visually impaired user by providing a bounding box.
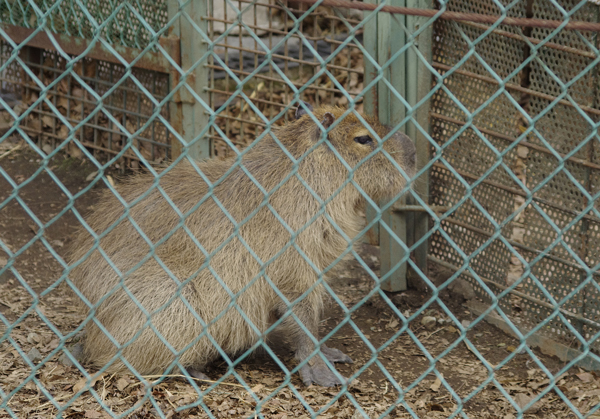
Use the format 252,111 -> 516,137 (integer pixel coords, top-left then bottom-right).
365,0 -> 432,291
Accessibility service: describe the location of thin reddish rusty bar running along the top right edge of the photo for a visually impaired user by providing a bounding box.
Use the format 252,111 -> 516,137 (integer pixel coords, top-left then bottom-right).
296,0 -> 600,32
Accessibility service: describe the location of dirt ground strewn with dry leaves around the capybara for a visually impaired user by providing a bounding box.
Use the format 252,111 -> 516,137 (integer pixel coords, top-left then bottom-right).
0,142 -> 600,419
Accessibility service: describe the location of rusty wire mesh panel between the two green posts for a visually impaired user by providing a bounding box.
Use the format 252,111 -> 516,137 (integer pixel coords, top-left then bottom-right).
208,0 -> 364,157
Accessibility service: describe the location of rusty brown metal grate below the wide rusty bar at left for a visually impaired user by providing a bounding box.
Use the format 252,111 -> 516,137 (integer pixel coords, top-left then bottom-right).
0,43 -> 170,169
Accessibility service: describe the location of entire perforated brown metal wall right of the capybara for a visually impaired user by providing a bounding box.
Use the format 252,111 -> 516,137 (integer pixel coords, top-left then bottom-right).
431,1 -> 600,354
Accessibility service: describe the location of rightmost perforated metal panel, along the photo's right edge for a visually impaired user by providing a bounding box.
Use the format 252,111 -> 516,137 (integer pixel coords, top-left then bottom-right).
524,1 -> 600,348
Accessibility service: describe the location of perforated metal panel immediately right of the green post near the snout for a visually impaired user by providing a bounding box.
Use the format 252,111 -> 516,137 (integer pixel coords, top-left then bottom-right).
431,1 -> 524,299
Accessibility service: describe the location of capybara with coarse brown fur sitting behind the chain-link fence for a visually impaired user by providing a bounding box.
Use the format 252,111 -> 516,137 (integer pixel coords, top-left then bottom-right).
69,105 -> 415,385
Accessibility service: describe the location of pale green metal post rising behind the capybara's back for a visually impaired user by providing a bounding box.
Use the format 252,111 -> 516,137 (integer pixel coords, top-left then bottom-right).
168,0 -> 211,160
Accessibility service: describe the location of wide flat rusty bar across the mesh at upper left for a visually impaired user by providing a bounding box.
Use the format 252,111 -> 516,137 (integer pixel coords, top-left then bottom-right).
0,23 -> 179,73
